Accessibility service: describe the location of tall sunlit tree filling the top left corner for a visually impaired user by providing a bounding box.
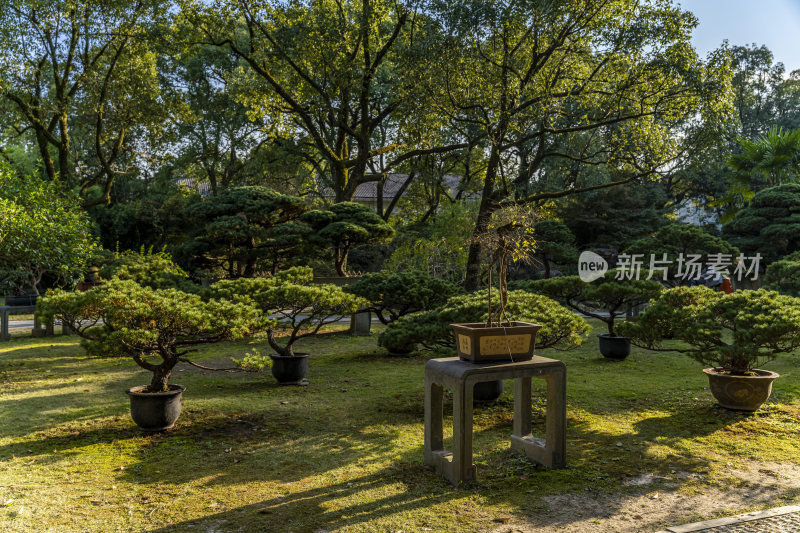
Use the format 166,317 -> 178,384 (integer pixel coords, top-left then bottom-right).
0,0 -> 166,206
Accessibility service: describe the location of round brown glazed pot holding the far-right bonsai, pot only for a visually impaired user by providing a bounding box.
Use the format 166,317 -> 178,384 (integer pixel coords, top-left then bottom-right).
703,368 -> 780,411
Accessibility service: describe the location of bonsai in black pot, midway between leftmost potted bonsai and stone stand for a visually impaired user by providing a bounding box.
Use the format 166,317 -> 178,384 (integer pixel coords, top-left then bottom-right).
211,278 -> 366,384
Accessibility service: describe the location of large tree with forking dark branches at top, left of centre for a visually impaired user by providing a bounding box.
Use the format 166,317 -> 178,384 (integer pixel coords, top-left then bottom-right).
185,0 -> 465,202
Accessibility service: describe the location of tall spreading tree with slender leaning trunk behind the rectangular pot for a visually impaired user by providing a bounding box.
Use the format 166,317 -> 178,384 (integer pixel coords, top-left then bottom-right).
424,0 -> 728,288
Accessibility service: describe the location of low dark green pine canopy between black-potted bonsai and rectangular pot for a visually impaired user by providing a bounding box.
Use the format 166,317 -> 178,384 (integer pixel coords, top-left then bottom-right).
344,270 -> 460,324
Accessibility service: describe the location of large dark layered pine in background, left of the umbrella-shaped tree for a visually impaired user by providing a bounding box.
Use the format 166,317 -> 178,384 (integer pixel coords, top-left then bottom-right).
179,186 -> 308,278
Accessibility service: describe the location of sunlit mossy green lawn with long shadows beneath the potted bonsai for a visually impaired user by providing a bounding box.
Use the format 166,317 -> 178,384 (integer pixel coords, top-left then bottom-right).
0,322 -> 800,533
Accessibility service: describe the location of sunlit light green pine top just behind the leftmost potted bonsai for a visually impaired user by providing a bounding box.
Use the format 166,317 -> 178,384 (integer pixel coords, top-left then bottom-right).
98,250 -> 198,292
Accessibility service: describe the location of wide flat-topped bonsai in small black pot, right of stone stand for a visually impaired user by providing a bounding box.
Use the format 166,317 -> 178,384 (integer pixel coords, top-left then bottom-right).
527,270 -> 663,360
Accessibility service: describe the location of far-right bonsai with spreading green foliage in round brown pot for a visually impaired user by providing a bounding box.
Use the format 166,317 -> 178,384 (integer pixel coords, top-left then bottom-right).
619,287 -> 800,411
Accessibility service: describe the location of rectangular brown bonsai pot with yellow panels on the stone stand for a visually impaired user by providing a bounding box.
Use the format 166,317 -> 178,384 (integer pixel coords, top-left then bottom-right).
450,322 -> 542,363
